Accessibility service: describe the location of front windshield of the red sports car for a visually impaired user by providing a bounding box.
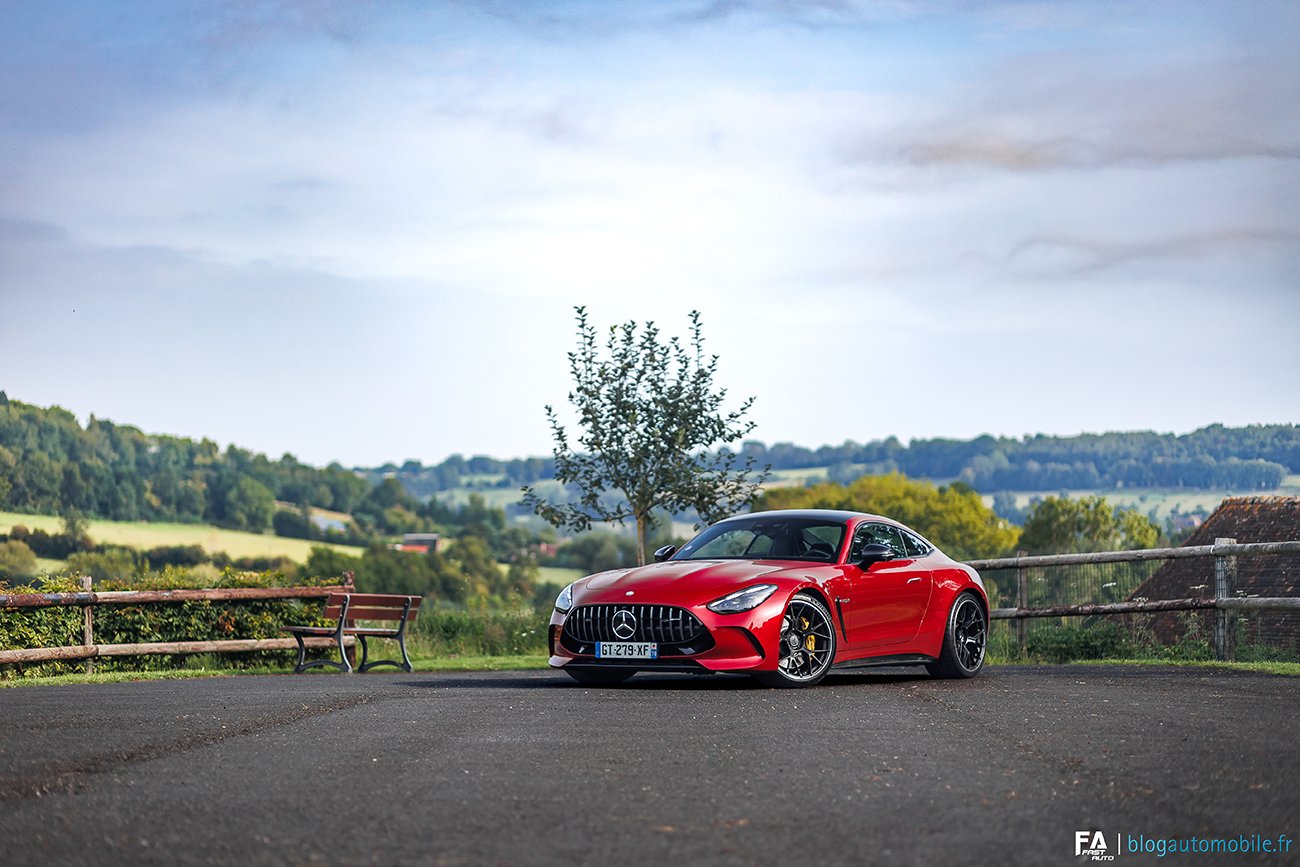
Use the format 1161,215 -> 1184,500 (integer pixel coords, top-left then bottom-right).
672,515 -> 844,563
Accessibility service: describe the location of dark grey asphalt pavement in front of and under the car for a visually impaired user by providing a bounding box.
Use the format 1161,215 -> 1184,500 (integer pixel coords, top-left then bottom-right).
0,666 -> 1300,867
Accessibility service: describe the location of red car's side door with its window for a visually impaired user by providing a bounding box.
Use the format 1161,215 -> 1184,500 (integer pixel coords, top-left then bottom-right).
848,521 -> 932,649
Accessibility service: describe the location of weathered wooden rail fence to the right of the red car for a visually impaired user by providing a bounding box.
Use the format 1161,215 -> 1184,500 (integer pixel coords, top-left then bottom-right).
966,538 -> 1300,660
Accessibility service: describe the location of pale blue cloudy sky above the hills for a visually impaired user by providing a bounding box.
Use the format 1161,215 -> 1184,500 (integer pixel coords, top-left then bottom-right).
0,0 -> 1300,465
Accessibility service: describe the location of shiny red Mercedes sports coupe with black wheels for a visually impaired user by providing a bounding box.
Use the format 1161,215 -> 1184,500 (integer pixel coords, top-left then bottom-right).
550,510 -> 988,686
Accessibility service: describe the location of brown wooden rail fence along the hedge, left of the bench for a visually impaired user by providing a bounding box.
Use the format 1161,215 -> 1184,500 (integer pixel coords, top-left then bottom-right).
0,576 -> 355,671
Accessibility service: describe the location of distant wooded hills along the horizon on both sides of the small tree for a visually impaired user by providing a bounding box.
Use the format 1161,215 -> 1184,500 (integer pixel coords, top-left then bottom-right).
0,391 -> 1300,536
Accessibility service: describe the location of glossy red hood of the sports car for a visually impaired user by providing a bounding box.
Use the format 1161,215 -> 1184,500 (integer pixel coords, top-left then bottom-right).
573,560 -> 826,606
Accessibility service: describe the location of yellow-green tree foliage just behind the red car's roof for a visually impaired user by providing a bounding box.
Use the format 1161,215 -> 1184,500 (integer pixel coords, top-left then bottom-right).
754,473 -> 1019,559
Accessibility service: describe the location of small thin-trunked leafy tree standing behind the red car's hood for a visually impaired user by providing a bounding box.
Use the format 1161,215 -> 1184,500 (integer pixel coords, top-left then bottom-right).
523,307 -> 767,563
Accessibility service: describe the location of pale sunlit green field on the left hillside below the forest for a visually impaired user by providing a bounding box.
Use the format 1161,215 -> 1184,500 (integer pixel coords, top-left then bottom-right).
0,512 -> 364,564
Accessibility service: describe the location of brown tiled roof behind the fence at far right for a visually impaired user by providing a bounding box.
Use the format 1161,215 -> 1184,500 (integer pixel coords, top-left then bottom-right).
1132,497 -> 1300,653
